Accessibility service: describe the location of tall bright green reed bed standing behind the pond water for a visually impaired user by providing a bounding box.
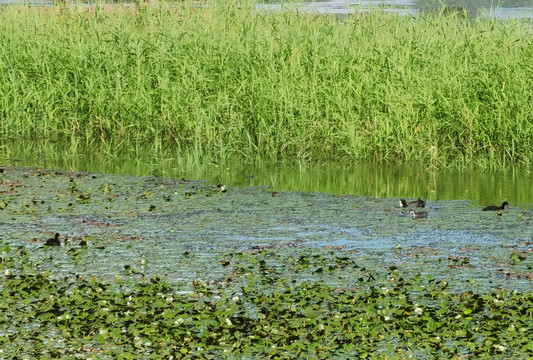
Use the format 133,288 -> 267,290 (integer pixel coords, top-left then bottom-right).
0,1 -> 533,168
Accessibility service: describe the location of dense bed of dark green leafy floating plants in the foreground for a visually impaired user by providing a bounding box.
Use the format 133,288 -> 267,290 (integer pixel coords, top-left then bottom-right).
0,246 -> 533,358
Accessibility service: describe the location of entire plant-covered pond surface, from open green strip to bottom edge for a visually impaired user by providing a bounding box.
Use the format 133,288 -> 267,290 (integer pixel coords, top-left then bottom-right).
0,167 -> 533,358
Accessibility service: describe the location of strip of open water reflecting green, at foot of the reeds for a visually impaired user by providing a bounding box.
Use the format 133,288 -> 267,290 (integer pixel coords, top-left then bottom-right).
0,142 -> 533,208
